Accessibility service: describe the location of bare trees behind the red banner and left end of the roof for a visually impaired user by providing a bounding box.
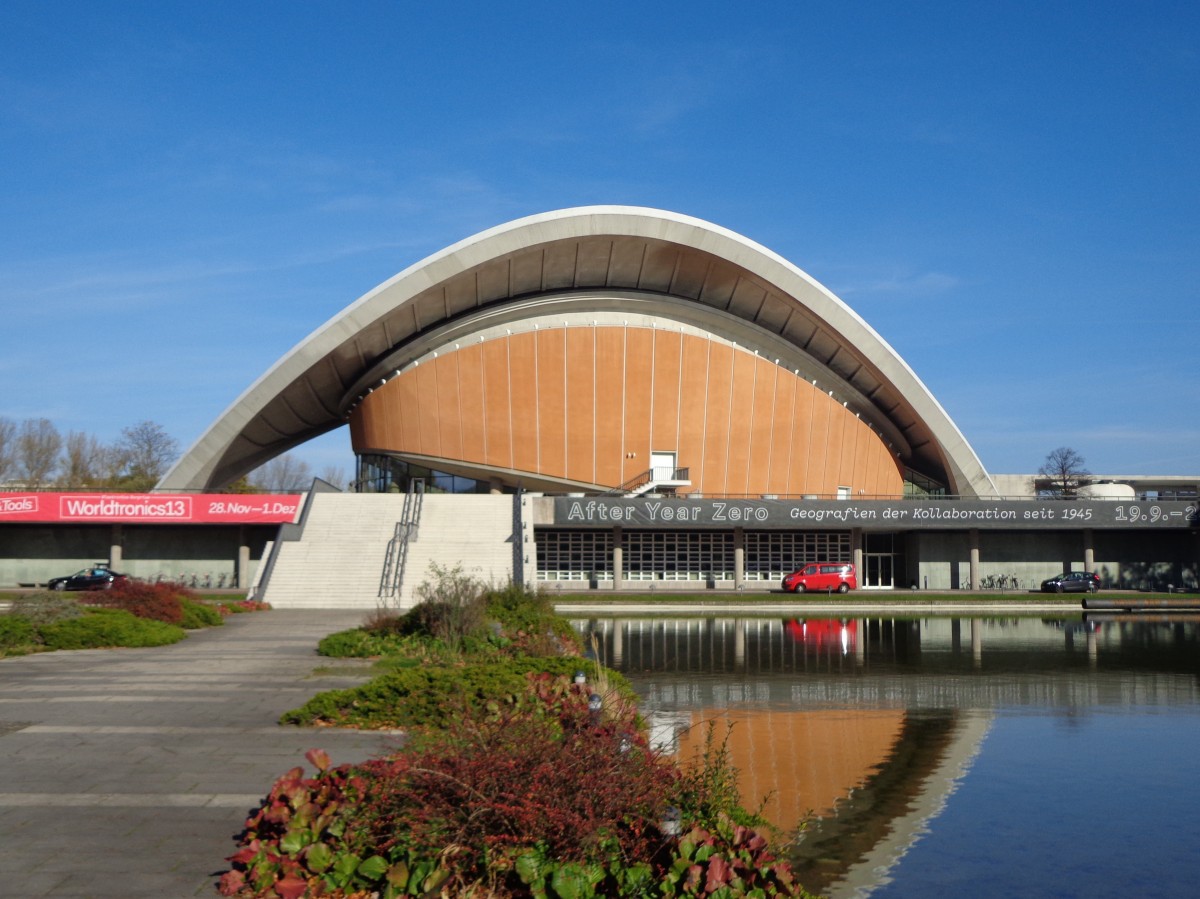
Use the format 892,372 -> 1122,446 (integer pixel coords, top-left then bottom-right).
0,416 -> 346,493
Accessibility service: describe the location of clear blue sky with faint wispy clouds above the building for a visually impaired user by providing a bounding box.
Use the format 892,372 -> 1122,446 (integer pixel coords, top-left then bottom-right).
0,0 -> 1200,474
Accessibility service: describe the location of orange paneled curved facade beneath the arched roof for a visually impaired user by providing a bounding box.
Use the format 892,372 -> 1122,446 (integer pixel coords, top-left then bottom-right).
350,325 -> 904,497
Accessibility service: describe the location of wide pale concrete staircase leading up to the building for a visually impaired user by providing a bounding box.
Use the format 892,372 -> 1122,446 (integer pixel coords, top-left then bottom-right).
259,493 -> 512,610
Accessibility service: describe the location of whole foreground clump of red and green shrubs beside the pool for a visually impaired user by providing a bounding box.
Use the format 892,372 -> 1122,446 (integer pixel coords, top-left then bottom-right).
220,676 -> 806,899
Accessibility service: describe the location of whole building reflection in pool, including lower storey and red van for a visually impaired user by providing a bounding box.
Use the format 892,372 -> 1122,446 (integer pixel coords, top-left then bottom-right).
575,616 -> 1200,895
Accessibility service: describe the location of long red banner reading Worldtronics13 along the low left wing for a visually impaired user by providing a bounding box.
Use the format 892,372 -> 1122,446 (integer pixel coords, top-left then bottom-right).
0,493 -> 301,525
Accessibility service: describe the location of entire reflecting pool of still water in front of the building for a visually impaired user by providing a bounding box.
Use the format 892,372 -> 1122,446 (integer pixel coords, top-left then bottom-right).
575,615 -> 1200,897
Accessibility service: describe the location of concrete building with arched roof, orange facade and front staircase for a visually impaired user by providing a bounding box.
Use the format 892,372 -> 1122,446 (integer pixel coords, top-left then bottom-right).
0,206 -> 1200,606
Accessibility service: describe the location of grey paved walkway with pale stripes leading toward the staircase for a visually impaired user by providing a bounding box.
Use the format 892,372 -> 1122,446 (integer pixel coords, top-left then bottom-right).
0,611 -> 396,899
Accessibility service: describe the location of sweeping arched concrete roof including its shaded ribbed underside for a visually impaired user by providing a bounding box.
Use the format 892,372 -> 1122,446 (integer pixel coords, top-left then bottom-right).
158,206 -> 996,496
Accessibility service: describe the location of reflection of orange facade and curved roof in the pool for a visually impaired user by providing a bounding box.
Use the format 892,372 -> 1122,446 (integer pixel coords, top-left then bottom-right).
650,706 -> 991,895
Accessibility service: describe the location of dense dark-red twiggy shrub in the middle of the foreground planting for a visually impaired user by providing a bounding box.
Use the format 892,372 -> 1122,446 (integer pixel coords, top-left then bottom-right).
347,678 -> 676,895
